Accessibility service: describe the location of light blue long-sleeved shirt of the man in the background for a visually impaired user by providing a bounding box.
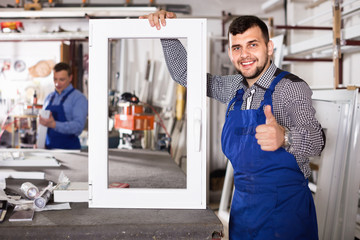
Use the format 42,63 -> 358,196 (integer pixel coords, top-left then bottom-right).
43,84 -> 88,136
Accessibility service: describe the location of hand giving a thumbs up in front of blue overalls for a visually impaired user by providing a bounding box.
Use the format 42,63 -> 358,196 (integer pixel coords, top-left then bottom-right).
255,105 -> 285,151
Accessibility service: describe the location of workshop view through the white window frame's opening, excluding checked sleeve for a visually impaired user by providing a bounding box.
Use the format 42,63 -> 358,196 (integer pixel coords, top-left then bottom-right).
108,38 -> 187,188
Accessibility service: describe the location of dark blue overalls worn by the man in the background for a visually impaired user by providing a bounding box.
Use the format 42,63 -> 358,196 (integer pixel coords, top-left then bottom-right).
45,88 -> 81,149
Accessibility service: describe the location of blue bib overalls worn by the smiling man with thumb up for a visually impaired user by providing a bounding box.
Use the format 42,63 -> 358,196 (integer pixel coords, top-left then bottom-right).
221,72 -> 318,240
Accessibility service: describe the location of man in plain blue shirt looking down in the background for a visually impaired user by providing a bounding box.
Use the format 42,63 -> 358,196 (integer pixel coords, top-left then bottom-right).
39,62 -> 88,149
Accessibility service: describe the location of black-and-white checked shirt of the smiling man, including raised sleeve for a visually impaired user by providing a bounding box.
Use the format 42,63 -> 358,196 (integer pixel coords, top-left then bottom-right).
161,39 -> 325,178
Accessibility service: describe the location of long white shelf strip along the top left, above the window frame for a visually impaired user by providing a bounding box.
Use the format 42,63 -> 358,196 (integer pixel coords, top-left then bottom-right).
0,7 -> 157,19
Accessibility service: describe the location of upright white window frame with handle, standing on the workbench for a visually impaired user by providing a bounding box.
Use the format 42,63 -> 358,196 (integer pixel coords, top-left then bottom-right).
89,19 -> 206,209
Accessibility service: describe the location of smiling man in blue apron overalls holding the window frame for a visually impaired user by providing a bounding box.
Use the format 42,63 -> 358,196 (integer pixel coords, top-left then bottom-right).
141,10 -> 325,240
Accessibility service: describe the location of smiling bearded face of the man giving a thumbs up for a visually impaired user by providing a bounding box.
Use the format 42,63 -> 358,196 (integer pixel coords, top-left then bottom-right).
228,26 -> 274,86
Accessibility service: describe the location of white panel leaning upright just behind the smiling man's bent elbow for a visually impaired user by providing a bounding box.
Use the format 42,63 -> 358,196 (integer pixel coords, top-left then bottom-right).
313,90 -> 357,240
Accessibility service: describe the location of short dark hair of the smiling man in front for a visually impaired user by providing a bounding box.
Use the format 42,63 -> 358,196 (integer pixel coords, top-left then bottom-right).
229,16 -> 269,44
